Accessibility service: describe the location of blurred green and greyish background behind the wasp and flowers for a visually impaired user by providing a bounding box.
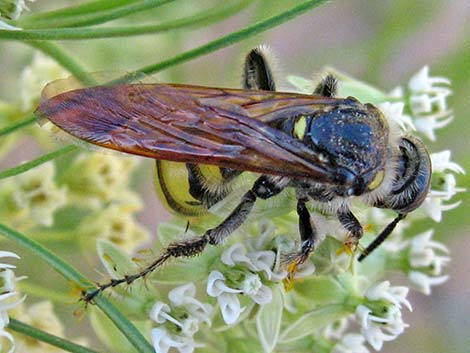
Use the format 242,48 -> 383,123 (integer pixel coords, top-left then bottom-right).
0,0 -> 470,353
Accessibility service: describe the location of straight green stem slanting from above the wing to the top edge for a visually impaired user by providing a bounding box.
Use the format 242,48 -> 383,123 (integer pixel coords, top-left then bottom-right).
119,0 -> 327,82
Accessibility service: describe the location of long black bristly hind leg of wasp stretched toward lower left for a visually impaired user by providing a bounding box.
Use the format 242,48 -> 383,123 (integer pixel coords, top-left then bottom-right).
82,176 -> 283,303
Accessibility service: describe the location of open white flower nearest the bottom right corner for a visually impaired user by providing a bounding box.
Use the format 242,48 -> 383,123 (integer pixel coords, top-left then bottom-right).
356,305 -> 408,351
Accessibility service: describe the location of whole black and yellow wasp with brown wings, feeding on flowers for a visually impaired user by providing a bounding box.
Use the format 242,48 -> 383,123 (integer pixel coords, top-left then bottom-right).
35,47 -> 431,302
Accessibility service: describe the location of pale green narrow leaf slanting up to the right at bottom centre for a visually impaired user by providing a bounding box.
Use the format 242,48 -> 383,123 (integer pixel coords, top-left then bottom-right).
279,304 -> 350,343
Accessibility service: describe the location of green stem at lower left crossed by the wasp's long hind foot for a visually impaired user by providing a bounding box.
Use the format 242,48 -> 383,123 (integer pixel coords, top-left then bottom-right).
0,224 -> 155,353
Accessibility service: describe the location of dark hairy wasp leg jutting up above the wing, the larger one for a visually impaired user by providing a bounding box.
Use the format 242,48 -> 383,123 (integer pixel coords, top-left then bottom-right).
243,46 -> 276,91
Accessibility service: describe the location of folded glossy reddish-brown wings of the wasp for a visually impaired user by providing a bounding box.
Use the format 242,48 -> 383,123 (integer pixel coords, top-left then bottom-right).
35,84 -> 337,182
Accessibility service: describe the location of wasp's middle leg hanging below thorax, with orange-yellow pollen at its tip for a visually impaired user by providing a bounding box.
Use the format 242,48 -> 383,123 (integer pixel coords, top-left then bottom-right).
286,198 -> 317,285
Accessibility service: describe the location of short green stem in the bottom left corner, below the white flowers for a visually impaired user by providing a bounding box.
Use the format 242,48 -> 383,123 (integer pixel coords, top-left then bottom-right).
8,319 -> 98,353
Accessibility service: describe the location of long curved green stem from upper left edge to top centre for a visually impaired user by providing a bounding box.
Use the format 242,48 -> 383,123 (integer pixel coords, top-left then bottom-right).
0,0 -> 252,40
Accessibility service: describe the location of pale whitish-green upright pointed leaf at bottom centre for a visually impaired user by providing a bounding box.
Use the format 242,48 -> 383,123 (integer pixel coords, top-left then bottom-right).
256,285 -> 284,353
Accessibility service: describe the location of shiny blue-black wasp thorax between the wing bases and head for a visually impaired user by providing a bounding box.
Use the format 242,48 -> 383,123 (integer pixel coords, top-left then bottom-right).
307,99 -> 389,196
